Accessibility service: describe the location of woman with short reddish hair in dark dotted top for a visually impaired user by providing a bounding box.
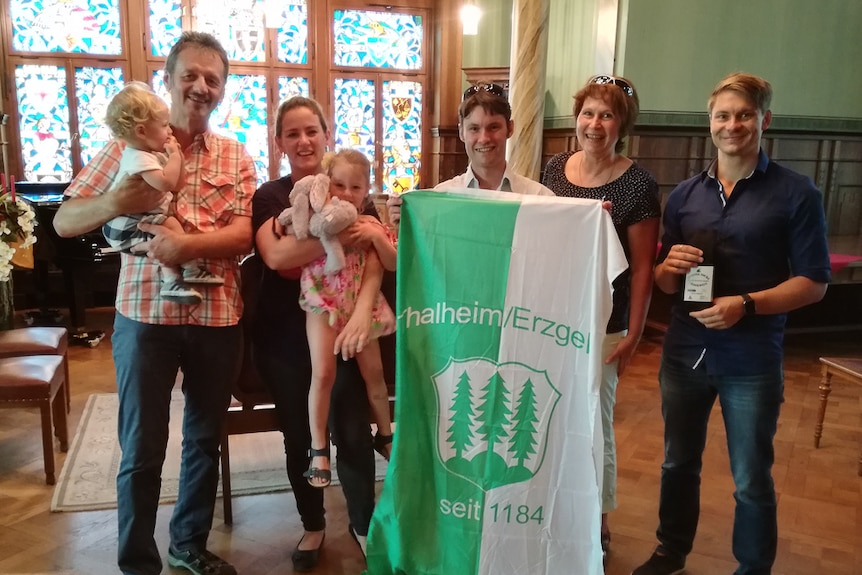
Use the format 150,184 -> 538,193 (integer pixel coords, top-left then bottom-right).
542,76 -> 661,553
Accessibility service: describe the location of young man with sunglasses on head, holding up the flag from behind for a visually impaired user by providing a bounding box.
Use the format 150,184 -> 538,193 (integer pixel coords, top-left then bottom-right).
387,82 -> 554,223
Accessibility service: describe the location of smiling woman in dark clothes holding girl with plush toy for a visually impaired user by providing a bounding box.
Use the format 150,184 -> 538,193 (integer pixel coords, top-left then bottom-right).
252,96 -> 380,572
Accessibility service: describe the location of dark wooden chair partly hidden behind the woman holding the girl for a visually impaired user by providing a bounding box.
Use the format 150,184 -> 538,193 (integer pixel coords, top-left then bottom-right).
221,255 -> 278,525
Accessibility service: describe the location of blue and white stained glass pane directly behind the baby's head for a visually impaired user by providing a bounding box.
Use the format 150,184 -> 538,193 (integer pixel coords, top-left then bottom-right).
75,67 -> 123,165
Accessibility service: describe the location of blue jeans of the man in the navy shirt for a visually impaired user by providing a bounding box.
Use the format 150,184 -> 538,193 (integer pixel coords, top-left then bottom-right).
656,356 -> 784,575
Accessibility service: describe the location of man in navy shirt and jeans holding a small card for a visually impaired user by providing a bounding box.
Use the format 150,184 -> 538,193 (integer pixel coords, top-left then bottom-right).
633,73 -> 831,575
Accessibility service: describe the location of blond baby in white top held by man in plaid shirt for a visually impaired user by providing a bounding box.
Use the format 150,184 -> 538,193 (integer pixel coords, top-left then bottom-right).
102,82 -> 224,304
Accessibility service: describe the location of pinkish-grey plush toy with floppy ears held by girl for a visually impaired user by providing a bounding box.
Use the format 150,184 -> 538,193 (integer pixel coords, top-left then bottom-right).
277,174 -> 359,275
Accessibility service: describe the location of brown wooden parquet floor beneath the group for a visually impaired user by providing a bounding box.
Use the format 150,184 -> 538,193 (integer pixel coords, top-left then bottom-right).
0,310 -> 862,575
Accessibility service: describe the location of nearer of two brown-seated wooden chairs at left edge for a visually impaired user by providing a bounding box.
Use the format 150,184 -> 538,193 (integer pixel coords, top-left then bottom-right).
0,355 -> 69,485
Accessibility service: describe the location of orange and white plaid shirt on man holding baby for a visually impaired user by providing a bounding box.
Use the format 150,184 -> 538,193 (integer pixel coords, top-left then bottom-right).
66,132 -> 257,327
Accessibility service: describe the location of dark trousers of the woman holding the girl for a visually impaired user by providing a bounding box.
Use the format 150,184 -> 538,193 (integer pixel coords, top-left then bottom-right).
254,346 -> 374,535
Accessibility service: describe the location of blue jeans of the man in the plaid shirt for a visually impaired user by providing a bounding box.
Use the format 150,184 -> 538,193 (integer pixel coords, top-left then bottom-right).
111,314 -> 242,575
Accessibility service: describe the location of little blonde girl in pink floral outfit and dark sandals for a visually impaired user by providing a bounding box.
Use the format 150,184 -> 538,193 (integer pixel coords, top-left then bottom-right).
299,149 -> 397,487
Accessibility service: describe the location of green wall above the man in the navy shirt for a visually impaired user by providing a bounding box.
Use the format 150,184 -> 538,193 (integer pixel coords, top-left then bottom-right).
617,0 -> 862,119
